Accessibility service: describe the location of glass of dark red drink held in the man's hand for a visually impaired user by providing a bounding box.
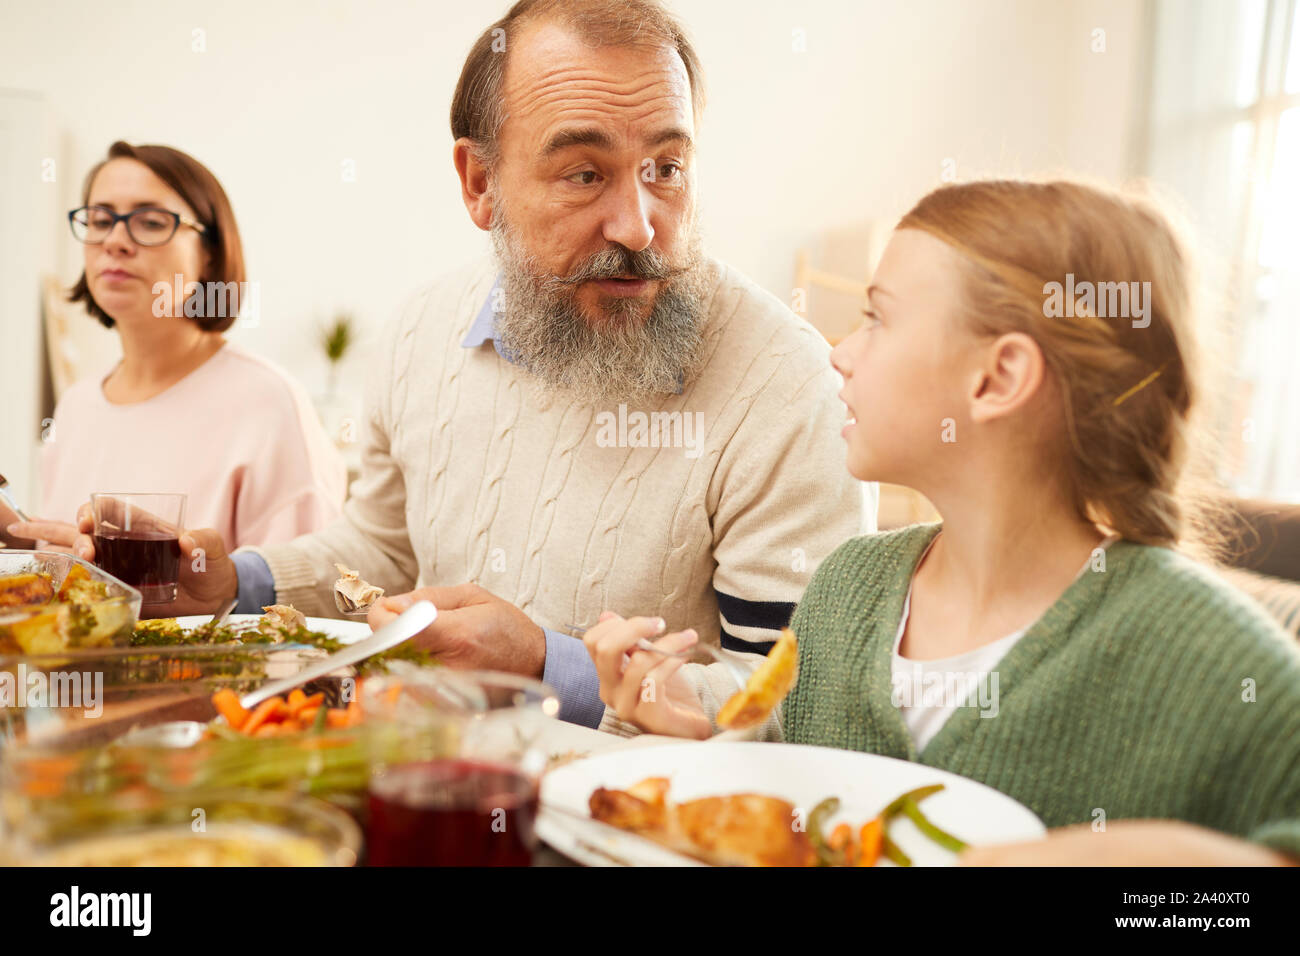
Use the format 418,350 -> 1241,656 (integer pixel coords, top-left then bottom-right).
90,492 -> 185,604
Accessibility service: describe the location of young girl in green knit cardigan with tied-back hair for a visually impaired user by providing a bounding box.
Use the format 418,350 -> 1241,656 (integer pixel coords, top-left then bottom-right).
585,182 -> 1300,864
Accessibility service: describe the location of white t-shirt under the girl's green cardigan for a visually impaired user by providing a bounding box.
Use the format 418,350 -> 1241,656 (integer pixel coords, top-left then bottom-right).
891,535 -> 1119,753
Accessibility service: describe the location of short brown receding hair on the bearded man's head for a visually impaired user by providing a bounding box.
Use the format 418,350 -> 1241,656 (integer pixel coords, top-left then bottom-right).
451,0 -> 705,166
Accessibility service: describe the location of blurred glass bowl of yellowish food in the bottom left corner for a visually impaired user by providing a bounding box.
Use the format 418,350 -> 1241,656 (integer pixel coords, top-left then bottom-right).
5,790 -> 361,866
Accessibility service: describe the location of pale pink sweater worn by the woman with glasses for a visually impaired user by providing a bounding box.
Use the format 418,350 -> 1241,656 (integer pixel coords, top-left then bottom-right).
42,342 -> 347,549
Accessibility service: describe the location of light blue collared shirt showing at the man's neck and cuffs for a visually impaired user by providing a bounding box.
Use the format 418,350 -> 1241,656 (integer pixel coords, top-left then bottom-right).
231,276 -> 605,727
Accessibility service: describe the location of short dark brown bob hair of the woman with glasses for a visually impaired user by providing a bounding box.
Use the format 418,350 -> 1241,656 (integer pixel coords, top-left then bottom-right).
68,139 -> 244,332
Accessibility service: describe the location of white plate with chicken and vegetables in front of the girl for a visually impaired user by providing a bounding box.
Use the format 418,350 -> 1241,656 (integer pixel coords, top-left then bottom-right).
537,741 -> 1045,866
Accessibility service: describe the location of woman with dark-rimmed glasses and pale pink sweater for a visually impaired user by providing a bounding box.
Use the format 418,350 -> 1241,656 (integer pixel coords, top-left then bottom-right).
10,142 -> 347,548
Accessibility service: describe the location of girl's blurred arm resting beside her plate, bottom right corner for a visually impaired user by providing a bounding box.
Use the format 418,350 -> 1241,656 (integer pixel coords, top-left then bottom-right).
957,819 -> 1296,866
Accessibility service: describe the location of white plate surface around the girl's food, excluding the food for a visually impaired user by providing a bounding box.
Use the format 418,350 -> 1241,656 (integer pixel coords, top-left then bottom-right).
537,743 -> 1047,866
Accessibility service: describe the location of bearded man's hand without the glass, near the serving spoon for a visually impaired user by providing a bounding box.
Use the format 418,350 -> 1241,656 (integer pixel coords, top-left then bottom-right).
368,584 -> 546,678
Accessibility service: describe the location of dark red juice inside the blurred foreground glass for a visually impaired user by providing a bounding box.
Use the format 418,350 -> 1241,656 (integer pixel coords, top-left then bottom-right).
367,758 -> 538,866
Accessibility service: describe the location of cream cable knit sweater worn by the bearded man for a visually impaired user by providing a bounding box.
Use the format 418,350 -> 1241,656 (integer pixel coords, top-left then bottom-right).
246,254 -> 875,658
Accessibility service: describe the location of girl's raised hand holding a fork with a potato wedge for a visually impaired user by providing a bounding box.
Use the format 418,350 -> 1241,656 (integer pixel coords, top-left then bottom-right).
582,611 -> 712,740
